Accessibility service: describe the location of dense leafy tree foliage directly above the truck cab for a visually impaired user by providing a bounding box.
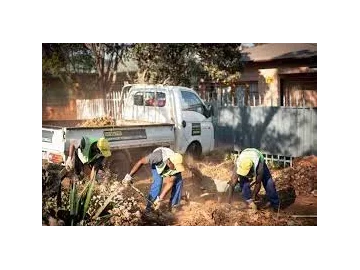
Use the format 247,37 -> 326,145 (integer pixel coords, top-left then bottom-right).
131,42 -> 242,86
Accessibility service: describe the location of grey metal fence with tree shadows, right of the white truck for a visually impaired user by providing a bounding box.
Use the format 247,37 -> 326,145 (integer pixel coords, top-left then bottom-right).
208,86 -> 319,157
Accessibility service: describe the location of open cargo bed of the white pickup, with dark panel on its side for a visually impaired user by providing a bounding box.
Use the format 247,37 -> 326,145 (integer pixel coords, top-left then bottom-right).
41,121 -> 175,161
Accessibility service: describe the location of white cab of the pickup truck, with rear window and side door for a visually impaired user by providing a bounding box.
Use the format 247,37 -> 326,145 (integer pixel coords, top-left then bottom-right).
122,85 -> 214,157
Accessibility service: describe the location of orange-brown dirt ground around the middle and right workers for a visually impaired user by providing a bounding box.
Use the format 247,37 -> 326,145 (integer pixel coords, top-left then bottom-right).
124,154 -> 319,226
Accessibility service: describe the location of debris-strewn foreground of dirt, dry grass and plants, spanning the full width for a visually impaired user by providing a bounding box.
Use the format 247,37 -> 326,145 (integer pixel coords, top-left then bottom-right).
42,155 -> 319,226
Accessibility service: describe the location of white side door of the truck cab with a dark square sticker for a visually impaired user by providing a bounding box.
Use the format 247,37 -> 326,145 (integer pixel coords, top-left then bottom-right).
179,89 -> 214,153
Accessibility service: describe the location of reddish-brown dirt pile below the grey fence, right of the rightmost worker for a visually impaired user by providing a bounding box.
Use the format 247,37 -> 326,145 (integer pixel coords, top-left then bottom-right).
271,156 -> 318,195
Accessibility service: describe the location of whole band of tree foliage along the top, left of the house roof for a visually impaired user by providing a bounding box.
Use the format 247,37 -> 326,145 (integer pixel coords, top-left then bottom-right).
40,41 -> 242,96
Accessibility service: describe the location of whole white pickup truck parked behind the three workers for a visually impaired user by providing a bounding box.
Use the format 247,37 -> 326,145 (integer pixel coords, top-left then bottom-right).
41,85 -> 214,177
